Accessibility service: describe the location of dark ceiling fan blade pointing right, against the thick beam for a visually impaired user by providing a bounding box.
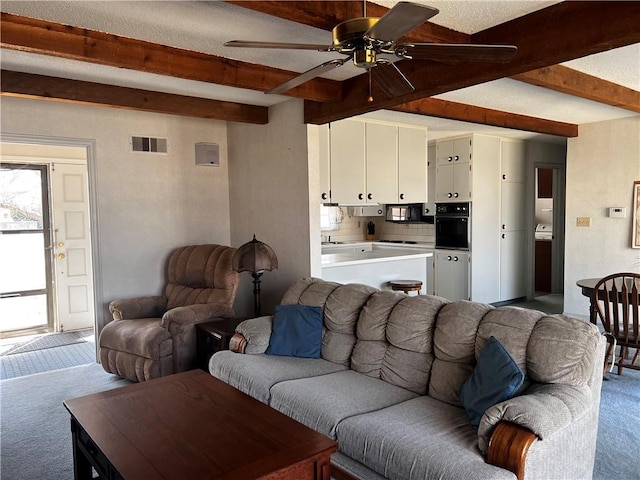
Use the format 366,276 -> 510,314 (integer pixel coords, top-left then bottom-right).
396,43 -> 518,63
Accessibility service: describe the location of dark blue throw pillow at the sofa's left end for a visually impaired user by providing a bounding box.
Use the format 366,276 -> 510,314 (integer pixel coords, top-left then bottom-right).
266,305 -> 323,358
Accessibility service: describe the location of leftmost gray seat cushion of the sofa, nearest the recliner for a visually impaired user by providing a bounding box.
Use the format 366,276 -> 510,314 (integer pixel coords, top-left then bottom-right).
209,350 -> 347,404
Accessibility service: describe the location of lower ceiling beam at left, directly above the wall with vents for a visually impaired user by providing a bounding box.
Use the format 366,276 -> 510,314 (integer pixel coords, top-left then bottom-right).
0,70 -> 269,125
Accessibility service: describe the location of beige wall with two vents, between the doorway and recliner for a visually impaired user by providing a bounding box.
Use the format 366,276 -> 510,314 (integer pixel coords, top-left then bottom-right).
1,97 -> 230,326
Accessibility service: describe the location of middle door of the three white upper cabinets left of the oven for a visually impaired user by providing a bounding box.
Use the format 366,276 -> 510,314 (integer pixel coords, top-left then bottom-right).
365,123 -> 398,203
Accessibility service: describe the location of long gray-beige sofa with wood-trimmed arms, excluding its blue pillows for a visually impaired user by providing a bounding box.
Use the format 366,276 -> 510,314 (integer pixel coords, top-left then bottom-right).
209,278 -> 606,480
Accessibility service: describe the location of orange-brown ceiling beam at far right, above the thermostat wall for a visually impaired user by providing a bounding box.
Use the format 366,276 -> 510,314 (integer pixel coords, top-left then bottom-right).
511,65 -> 640,112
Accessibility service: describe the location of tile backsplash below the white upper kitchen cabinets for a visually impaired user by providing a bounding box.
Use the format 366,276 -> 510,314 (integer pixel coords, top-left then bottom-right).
322,207 -> 435,242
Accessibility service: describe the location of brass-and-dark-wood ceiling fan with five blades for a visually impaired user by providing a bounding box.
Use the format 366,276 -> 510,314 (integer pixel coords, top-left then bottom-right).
224,0 -> 517,101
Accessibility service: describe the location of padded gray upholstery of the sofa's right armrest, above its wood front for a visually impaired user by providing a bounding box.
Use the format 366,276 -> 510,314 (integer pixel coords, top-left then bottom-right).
478,383 -> 597,453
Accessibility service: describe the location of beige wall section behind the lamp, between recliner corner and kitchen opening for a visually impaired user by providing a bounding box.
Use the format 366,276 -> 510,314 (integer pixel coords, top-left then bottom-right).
228,100 -> 312,315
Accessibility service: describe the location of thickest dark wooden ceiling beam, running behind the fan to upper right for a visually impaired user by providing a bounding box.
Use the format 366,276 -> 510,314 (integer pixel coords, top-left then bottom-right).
305,1 -> 640,123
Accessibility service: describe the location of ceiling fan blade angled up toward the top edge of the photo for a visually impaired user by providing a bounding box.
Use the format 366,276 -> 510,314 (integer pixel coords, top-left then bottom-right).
364,2 -> 438,42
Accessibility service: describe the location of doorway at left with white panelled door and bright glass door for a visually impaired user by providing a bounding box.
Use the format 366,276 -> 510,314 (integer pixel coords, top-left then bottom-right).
0,142 -> 96,344
